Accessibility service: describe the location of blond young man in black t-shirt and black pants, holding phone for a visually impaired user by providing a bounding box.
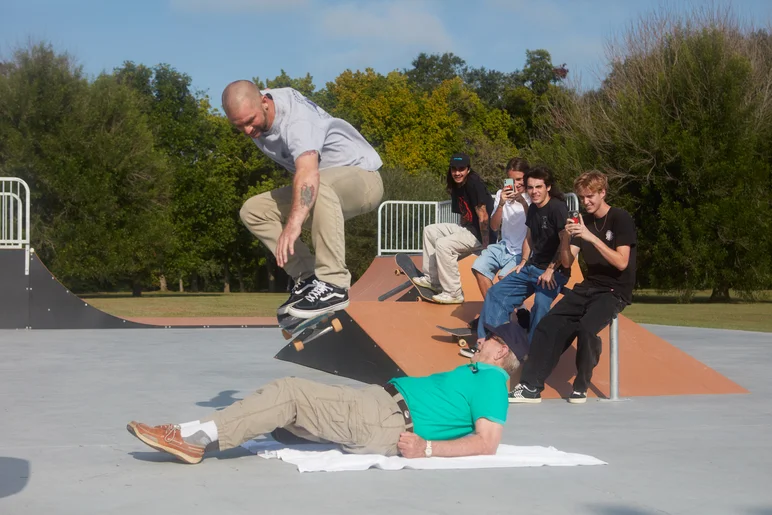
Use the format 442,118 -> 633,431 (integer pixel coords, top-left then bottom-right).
509,171 -> 636,404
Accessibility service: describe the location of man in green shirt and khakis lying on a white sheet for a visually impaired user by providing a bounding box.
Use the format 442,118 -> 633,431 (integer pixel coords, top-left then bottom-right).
127,323 -> 528,463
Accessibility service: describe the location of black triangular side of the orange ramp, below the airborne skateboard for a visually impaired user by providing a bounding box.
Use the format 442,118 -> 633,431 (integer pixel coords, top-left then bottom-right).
275,310 -> 405,384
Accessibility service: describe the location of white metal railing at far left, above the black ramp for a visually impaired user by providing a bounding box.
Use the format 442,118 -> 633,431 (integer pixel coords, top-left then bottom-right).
0,177 -> 30,249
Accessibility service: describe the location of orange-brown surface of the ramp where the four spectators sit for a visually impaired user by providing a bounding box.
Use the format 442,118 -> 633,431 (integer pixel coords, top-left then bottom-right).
282,256 -> 747,398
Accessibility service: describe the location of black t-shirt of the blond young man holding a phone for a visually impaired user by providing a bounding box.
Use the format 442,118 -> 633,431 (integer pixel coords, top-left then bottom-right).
571,207 -> 638,304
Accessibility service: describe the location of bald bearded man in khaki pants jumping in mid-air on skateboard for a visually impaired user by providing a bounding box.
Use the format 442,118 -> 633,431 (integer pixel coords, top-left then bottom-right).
222,80 -> 383,318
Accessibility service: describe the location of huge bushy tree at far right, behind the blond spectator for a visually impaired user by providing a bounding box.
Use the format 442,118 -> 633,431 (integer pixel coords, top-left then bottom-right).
534,12 -> 772,299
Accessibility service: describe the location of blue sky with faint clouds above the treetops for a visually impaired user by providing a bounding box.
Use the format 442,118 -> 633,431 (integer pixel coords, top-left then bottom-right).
0,0 -> 772,98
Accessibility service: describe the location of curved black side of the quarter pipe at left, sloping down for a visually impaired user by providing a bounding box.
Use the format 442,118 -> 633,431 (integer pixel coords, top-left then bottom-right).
29,254 -> 150,329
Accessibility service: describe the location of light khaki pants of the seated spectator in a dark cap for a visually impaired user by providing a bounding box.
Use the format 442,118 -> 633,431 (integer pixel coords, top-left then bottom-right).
423,224 -> 482,295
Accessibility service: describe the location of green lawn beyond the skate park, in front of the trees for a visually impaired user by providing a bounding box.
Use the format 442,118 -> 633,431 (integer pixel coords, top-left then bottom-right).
82,290 -> 772,332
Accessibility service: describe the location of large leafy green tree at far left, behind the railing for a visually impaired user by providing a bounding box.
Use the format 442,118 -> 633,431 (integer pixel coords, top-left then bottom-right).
0,44 -> 170,293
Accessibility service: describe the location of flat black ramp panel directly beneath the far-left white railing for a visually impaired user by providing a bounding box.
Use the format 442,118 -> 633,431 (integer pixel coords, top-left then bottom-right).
0,249 -> 29,329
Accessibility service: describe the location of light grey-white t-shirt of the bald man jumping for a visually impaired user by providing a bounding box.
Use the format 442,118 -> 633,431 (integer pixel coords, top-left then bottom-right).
252,88 -> 383,173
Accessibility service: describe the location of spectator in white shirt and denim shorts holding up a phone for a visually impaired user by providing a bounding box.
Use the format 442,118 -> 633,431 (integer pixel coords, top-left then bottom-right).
472,157 -> 531,298
